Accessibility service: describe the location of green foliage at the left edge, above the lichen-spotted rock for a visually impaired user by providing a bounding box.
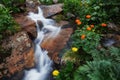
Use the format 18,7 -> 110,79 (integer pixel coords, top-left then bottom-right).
0,4 -> 20,54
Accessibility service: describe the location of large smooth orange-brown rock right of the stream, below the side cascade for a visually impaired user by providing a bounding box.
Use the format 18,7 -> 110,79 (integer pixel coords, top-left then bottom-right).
41,24 -> 73,63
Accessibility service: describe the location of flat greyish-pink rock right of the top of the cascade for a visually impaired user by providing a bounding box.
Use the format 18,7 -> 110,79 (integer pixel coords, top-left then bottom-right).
40,4 -> 63,17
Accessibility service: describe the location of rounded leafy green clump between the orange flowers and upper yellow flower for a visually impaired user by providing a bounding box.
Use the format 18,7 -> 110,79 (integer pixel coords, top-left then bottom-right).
72,26 -> 100,53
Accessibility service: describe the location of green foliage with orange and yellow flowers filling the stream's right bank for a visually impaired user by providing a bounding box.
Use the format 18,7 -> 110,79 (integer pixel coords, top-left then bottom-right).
56,0 -> 120,80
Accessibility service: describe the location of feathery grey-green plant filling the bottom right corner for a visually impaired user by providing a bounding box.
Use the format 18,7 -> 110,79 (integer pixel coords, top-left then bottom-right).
74,47 -> 120,80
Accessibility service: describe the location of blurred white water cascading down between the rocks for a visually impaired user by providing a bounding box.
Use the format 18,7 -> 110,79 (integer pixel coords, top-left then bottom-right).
23,8 -> 61,80
